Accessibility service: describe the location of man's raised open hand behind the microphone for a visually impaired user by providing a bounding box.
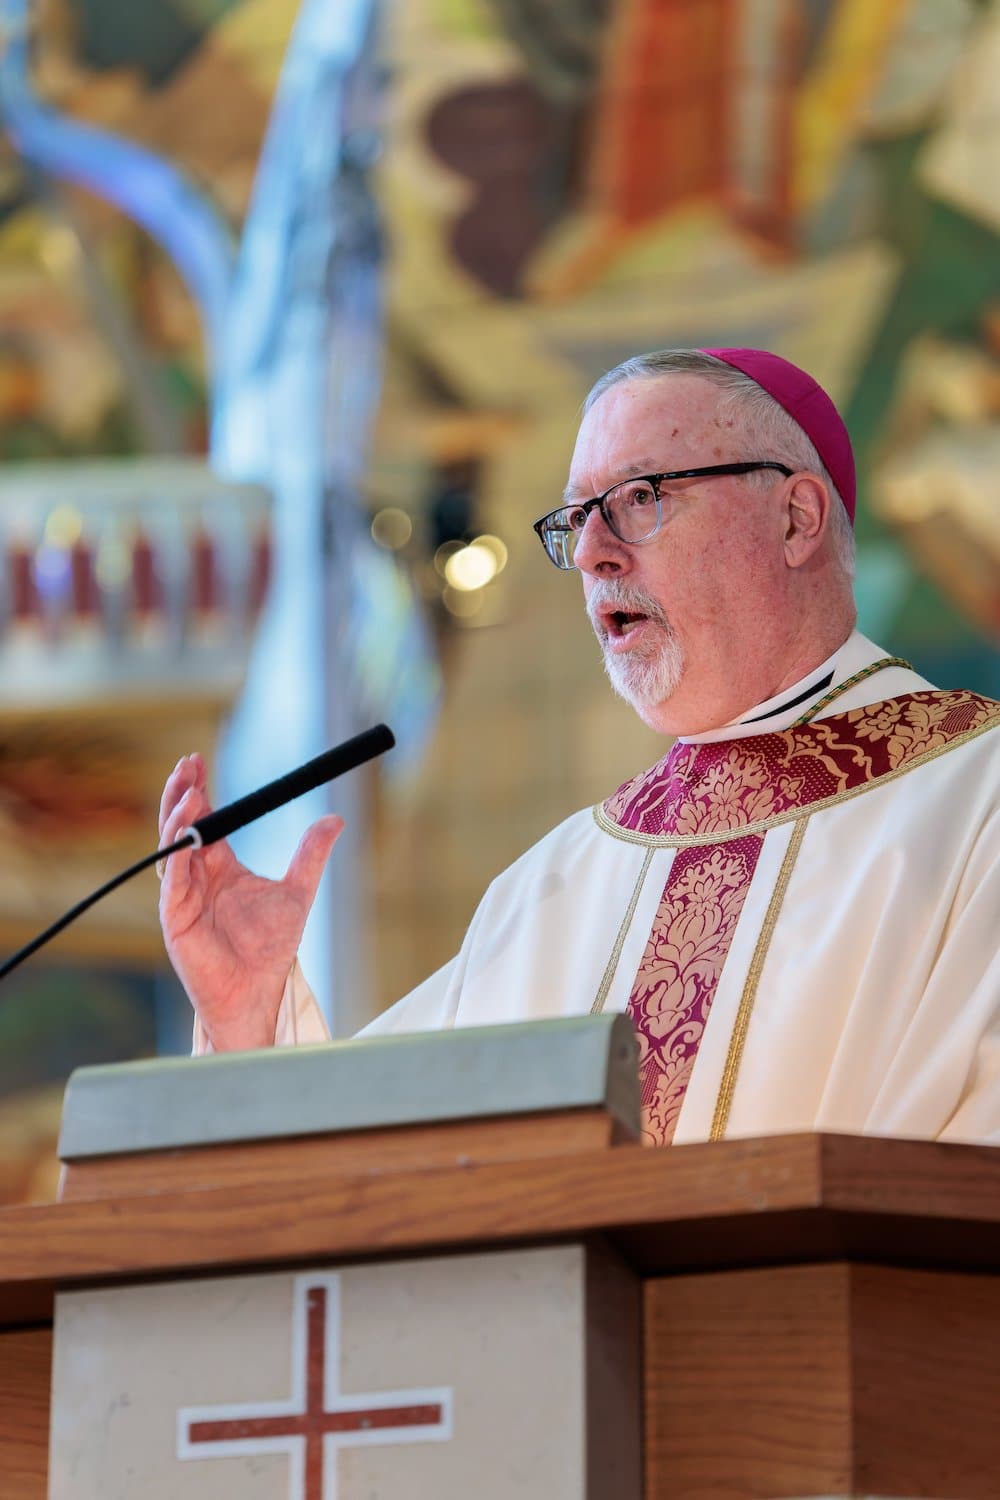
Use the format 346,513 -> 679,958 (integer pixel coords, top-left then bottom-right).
159,755 -> 343,1052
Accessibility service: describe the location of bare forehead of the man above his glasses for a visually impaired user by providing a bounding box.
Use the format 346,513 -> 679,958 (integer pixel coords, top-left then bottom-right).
570,375 -> 736,489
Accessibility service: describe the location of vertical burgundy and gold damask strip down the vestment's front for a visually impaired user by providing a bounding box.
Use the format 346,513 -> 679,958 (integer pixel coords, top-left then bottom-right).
628,834 -> 763,1146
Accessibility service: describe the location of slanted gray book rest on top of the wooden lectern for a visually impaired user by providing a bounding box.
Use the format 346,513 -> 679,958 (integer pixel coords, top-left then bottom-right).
58,1014 -> 639,1163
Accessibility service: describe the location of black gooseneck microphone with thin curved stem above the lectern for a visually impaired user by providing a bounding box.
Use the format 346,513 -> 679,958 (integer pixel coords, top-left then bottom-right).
0,725 -> 396,980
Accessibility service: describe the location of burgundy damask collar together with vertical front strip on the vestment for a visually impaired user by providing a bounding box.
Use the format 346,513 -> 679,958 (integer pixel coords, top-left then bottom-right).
614,692 -> 1000,1145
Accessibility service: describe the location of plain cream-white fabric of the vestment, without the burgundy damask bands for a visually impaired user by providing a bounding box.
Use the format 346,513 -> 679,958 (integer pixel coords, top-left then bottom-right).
193,633 -> 1000,1143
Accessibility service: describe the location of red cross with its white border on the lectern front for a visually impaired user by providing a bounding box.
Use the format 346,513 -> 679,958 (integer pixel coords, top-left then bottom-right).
178,1275 -> 451,1500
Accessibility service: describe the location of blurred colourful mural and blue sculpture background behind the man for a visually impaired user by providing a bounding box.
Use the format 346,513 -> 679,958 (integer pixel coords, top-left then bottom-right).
0,0 -> 1000,1199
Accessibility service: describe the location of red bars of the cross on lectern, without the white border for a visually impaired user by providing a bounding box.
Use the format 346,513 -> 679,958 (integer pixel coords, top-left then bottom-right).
187,1284 -> 450,1500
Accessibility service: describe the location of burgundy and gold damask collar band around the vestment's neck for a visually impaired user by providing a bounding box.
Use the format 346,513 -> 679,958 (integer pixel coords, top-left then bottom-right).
603,692 -> 1000,836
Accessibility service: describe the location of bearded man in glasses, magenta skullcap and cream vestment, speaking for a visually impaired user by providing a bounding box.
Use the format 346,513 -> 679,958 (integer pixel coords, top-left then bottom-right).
160,350 -> 1000,1143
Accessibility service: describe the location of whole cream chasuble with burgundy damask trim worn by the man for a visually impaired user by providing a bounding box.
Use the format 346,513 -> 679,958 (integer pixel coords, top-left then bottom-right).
196,633 -> 1000,1145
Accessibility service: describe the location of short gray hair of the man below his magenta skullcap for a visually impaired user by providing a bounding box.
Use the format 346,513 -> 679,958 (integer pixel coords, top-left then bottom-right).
583,350 -> 855,578
